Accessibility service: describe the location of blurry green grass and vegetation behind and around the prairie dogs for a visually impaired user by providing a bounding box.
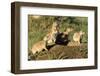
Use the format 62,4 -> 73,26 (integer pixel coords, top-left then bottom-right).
28,15 -> 88,59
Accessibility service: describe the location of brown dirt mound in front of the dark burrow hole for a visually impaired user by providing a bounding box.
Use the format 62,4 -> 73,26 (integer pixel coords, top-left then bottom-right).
28,44 -> 87,60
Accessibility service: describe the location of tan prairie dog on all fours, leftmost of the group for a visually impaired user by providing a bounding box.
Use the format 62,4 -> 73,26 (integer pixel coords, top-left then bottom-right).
31,39 -> 48,54
